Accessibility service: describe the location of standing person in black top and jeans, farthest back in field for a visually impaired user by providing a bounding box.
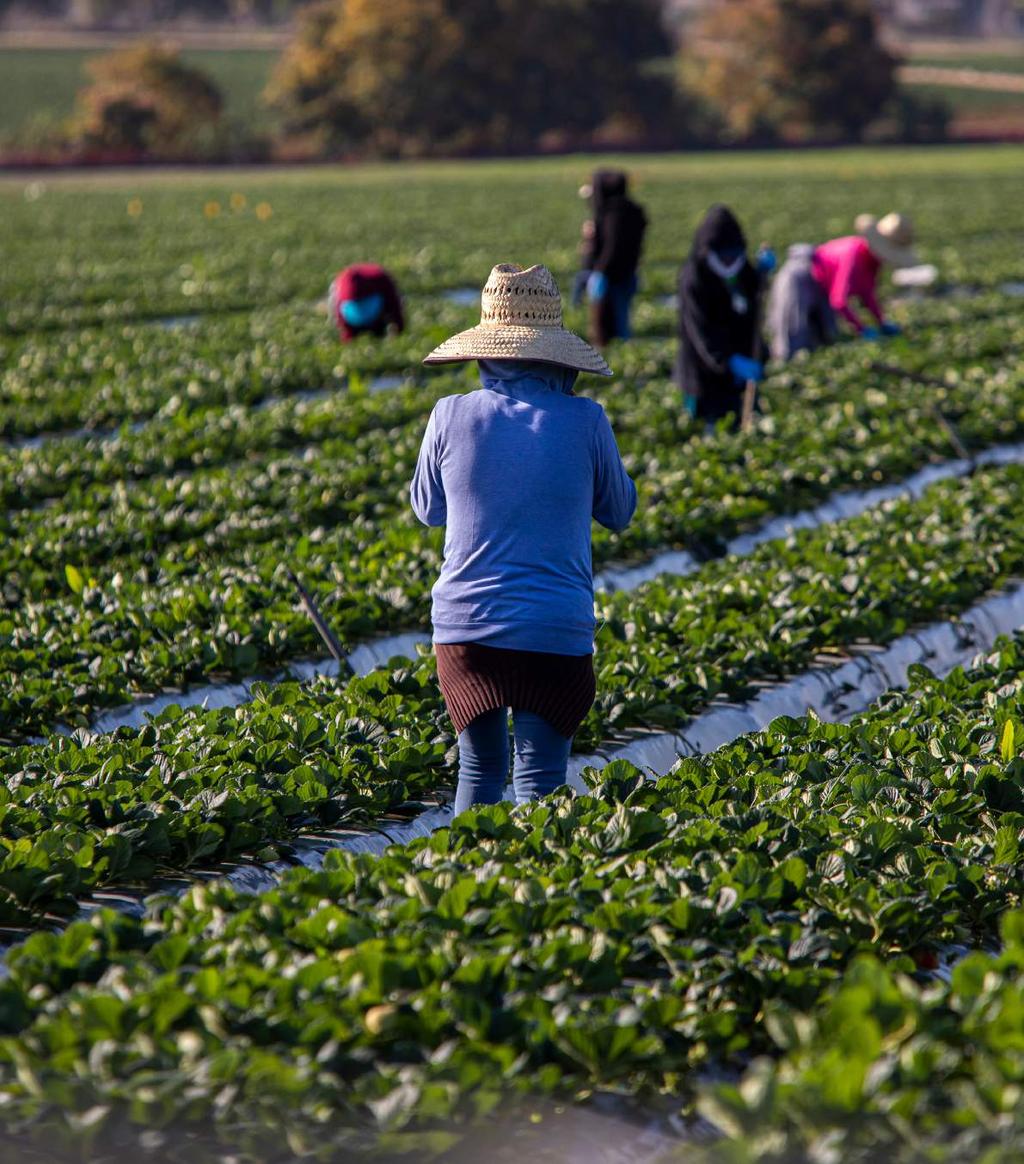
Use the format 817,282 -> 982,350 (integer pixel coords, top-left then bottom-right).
583,170 -> 647,348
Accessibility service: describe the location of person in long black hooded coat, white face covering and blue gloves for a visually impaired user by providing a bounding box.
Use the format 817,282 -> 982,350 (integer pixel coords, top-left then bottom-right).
676,205 -> 775,427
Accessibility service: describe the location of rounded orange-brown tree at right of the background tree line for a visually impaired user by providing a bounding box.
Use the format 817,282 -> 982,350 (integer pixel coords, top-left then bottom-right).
697,0 -> 897,140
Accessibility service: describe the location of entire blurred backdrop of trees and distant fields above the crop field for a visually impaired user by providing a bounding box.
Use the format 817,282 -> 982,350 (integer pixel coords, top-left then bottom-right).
0,0 -> 1024,162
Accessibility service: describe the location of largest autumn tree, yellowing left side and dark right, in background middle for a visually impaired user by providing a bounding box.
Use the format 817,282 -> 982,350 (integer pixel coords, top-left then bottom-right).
270,0 -> 673,154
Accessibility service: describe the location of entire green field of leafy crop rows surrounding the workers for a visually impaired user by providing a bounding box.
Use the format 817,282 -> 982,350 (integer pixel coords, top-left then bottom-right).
0,147 -> 1024,1164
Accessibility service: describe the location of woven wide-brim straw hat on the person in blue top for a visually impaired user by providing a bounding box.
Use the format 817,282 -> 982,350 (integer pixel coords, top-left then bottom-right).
424,263 -> 613,376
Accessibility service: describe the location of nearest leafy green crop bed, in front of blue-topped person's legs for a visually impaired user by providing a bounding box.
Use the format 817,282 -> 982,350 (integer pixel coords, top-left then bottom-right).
0,640 -> 1024,1162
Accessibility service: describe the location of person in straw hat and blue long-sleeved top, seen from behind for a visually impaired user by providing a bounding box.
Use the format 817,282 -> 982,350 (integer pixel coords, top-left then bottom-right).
412,263 -> 637,812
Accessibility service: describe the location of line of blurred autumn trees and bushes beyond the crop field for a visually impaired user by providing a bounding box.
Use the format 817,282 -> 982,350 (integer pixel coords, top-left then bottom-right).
6,0 -> 945,164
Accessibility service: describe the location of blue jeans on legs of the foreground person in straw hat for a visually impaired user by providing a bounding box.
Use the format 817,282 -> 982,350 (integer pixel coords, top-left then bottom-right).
455,708 -> 573,814
